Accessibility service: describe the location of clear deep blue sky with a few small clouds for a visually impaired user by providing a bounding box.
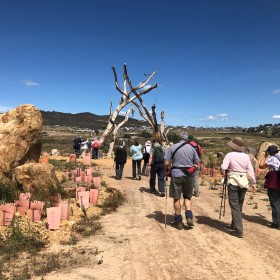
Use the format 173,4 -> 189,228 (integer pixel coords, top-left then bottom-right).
0,0 -> 280,127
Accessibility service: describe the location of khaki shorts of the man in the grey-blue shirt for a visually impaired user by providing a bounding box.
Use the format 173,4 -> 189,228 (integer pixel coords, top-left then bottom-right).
169,175 -> 195,200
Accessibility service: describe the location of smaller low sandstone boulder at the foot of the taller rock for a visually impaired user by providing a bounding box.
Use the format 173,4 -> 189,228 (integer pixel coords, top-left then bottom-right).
14,163 -> 60,194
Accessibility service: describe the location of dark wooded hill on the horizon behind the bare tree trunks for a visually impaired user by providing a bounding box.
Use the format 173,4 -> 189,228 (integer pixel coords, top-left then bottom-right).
41,111 -> 148,130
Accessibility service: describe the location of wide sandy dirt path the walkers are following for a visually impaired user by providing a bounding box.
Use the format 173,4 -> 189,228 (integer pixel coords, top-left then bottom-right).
44,159 -> 280,280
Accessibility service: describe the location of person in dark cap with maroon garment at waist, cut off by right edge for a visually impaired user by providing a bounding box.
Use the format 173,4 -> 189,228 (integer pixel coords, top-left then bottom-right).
259,145 -> 280,230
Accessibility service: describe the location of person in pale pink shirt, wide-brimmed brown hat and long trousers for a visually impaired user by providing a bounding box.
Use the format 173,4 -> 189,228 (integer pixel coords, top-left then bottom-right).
221,137 -> 256,238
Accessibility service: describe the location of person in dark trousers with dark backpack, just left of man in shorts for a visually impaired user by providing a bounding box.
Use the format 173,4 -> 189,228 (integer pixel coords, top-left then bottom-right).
148,140 -> 165,197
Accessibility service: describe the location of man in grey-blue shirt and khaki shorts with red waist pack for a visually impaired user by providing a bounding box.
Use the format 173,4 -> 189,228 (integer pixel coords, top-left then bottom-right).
164,132 -> 199,230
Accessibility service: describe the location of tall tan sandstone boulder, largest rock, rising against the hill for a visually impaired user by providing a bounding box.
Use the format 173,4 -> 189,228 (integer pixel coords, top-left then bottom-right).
0,104 -> 43,184
